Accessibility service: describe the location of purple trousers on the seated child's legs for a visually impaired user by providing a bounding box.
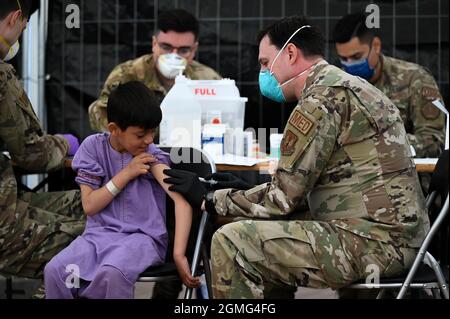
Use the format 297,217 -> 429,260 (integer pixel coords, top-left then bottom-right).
44,258 -> 134,299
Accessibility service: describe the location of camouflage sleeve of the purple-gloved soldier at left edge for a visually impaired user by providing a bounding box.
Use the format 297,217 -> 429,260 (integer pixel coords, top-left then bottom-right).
0,70 -> 69,172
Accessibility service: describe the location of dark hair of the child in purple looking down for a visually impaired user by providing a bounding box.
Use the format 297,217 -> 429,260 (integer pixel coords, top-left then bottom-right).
106,81 -> 162,130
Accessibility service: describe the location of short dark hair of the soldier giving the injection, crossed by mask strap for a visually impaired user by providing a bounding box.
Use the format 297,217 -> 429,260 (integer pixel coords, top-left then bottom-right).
257,16 -> 325,57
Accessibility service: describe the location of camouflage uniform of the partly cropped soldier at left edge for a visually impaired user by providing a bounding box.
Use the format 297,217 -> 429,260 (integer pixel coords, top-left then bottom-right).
0,61 -> 85,278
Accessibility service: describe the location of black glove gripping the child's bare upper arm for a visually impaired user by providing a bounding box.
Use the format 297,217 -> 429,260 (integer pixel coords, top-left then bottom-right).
164,169 -> 207,208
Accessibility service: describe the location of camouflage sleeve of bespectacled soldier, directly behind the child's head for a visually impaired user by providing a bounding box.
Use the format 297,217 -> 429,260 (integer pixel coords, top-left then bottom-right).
89,61 -> 137,132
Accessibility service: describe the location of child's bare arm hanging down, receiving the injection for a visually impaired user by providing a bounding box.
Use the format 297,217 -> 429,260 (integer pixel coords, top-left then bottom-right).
151,164 -> 200,287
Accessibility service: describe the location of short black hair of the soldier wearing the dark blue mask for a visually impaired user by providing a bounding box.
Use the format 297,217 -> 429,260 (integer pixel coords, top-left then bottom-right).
333,13 -> 376,44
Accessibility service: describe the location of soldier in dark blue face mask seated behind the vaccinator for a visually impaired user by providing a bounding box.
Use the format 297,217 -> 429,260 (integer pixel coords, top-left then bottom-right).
334,13 -> 445,158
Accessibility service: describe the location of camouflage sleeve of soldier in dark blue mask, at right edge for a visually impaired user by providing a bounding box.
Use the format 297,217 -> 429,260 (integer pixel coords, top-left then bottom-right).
408,70 -> 445,157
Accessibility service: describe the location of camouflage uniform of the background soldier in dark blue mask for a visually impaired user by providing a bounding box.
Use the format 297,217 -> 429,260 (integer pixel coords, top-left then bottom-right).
373,56 -> 445,158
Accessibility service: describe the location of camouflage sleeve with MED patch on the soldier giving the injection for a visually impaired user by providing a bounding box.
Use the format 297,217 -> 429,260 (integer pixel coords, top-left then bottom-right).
214,95 -> 340,218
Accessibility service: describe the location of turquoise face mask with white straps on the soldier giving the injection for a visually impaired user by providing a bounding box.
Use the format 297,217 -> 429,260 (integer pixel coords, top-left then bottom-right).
259,25 -> 311,103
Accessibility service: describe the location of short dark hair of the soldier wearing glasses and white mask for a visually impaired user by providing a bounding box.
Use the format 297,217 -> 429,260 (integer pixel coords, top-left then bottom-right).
157,9 -> 199,40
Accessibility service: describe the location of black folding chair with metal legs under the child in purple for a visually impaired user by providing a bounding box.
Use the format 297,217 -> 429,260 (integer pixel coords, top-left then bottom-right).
137,147 -> 216,299
